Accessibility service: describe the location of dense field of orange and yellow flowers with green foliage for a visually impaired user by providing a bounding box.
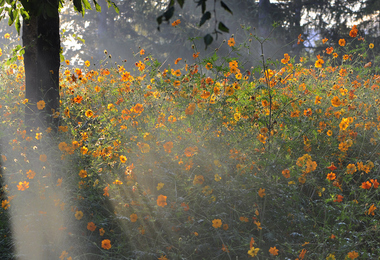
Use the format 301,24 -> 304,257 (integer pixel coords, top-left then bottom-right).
0,21 -> 380,260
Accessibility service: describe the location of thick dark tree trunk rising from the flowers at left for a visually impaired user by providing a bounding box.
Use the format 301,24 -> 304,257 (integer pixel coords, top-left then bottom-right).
22,0 -> 60,130
